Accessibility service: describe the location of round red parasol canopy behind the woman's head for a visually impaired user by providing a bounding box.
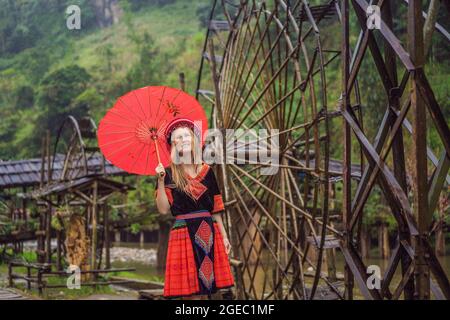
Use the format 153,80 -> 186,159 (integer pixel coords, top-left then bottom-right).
97,86 -> 208,175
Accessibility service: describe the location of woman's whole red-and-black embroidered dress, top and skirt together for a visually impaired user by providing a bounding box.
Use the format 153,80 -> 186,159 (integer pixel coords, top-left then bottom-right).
156,164 -> 234,297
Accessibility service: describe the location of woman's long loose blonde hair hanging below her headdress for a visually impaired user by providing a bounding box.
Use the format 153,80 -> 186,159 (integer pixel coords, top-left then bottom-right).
170,127 -> 202,200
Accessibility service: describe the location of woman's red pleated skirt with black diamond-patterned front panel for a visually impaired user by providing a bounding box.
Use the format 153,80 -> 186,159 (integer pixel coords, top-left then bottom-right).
164,211 -> 234,298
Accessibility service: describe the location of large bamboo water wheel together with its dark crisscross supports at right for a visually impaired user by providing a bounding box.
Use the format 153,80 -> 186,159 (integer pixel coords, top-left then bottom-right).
196,0 -> 450,299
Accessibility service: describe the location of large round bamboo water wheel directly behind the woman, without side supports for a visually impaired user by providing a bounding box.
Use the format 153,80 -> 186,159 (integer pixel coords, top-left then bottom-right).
197,1 -> 339,299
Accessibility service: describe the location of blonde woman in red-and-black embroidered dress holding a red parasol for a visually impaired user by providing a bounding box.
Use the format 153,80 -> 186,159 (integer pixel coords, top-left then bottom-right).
156,119 -> 234,299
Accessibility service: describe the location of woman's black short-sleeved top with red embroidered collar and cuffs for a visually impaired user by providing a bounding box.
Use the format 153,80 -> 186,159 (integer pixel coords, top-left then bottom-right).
156,163 -> 224,216
